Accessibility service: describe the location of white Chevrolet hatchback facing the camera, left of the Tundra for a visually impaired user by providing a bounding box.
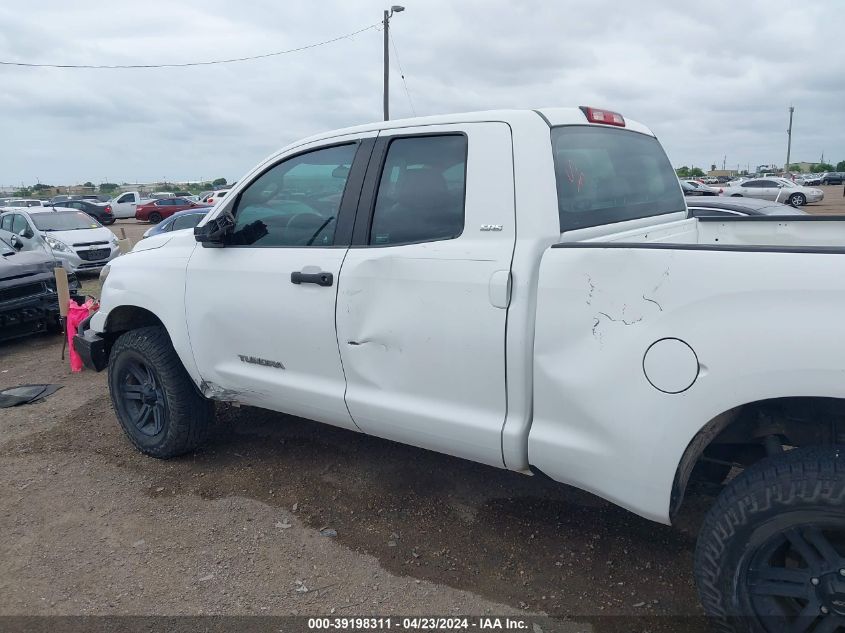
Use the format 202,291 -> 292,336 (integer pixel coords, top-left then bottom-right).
0,207 -> 120,272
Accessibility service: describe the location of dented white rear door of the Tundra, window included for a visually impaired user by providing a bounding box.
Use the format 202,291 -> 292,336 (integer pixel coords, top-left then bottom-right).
337,123 -> 516,467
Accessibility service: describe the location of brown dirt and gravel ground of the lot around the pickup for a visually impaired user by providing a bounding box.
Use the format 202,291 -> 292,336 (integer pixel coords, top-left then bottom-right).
0,187 -> 845,631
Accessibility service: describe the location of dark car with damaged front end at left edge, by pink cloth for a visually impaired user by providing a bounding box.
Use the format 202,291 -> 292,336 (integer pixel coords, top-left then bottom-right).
0,229 -> 79,341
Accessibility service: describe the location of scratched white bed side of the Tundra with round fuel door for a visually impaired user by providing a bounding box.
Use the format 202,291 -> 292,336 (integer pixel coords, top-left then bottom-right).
529,216 -> 845,522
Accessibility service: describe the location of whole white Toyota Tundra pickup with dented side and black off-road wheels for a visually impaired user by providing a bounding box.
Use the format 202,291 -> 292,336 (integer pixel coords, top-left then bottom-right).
75,107 -> 845,631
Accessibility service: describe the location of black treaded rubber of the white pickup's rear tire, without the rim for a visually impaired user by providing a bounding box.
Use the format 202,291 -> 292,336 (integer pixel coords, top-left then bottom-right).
695,446 -> 845,633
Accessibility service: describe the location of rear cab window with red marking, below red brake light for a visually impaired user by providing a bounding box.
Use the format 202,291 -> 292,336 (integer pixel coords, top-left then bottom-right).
552,125 -> 686,232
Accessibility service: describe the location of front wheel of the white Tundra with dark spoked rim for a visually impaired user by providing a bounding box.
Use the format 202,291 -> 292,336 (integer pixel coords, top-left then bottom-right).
109,327 -> 214,459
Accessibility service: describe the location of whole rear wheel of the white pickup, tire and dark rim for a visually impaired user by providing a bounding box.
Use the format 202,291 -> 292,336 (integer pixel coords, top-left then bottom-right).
695,446 -> 845,632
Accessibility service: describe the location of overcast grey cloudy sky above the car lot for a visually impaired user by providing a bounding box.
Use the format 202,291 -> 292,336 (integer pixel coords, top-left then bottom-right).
0,0 -> 845,185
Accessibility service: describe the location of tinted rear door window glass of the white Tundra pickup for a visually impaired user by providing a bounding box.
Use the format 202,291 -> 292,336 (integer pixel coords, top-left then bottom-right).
370,135 -> 467,245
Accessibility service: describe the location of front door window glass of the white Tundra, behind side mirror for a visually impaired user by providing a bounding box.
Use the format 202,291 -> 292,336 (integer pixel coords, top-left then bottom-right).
227,143 -> 358,246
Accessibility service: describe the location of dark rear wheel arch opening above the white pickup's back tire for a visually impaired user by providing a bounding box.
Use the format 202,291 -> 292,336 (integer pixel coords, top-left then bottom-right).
669,396 -> 845,518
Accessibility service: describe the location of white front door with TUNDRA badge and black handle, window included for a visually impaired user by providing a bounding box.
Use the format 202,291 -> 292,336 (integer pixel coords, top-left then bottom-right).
185,138 -> 373,428
